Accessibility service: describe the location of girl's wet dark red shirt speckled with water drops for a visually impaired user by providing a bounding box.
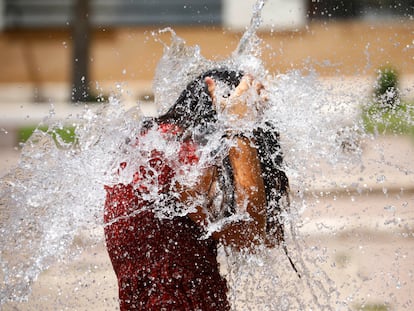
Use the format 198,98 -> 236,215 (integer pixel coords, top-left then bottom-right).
104,126 -> 230,311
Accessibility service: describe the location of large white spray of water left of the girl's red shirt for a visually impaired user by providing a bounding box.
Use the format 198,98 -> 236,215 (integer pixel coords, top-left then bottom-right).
0,99 -> 142,303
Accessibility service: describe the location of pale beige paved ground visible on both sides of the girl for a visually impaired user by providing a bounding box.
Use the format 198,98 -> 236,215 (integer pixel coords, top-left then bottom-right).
0,133 -> 414,310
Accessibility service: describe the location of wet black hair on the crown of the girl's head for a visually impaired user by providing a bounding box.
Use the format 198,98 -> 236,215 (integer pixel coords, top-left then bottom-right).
154,68 -> 243,130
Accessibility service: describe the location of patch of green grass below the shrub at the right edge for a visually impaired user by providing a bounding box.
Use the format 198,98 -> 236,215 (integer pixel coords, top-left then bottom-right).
362,101 -> 414,138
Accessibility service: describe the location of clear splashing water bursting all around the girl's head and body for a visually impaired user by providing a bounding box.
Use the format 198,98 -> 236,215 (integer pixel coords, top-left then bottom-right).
0,1 -> 382,310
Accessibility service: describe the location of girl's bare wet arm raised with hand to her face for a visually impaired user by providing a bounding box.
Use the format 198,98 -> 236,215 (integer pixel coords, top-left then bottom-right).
206,76 -> 266,249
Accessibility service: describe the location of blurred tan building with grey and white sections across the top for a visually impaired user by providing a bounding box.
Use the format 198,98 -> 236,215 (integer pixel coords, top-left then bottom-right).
0,0 -> 414,88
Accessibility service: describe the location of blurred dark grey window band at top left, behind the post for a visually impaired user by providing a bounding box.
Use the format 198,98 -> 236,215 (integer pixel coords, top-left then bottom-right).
0,0 -> 222,29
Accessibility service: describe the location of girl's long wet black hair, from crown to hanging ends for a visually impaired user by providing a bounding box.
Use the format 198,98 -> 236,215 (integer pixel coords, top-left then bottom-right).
144,68 -> 300,277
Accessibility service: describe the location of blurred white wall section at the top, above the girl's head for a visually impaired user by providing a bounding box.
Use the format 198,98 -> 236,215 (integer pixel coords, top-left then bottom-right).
223,0 -> 306,31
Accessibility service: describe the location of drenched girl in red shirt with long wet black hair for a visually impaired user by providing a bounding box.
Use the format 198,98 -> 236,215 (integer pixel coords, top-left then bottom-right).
104,69 -> 288,311
